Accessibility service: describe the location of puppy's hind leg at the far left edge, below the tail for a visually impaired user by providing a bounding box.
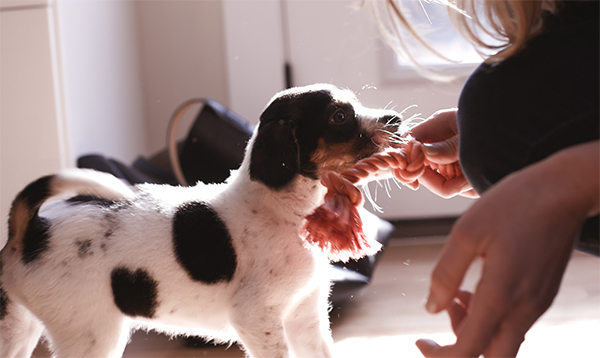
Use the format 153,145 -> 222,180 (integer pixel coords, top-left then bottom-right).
0,301 -> 44,358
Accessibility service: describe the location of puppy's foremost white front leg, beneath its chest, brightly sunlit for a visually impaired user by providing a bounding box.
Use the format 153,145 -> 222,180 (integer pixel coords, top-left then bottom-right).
284,286 -> 333,358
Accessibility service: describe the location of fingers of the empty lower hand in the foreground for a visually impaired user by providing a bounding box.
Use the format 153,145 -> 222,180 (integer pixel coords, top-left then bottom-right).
417,232 -> 531,357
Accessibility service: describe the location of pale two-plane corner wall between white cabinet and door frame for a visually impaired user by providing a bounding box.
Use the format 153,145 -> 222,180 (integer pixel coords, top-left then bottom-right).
56,0 -> 228,164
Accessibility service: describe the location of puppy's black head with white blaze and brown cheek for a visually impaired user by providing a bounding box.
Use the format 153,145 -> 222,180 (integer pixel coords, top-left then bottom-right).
250,84 -> 400,190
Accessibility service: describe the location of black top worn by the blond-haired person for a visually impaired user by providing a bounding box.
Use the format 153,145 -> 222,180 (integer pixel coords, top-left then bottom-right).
458,1 -> 600,256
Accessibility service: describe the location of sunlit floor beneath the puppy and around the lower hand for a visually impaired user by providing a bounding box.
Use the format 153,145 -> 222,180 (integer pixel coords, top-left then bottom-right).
34,237 -> 600,358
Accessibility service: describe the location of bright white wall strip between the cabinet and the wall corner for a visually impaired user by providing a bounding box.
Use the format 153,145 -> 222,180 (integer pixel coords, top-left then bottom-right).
56,0 -> 147,162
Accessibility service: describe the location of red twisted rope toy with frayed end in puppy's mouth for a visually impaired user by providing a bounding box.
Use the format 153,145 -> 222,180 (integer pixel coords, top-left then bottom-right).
300,138 -> 460,262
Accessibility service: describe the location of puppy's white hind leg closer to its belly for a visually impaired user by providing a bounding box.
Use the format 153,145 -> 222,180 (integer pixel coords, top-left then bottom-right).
46,311 -> 131,358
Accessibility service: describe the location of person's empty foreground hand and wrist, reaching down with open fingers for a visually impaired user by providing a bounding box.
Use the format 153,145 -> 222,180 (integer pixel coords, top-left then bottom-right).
417,142 -> 599,358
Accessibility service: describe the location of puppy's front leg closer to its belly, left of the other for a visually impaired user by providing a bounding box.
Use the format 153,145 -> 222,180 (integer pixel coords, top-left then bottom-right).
231,295 -> 289,358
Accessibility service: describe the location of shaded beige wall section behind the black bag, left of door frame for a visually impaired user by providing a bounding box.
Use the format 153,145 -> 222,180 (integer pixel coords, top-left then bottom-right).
136,0 -> 229,153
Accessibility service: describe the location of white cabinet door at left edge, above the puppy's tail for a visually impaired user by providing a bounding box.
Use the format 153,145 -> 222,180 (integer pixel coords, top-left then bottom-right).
0,4 -> 64,246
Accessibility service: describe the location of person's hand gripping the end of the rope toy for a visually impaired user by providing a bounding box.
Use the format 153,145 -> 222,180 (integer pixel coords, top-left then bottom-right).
411,108 -> 478,198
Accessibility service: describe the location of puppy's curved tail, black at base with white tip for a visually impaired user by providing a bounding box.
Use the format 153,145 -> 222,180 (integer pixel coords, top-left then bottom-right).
8,169 -> 135,248
